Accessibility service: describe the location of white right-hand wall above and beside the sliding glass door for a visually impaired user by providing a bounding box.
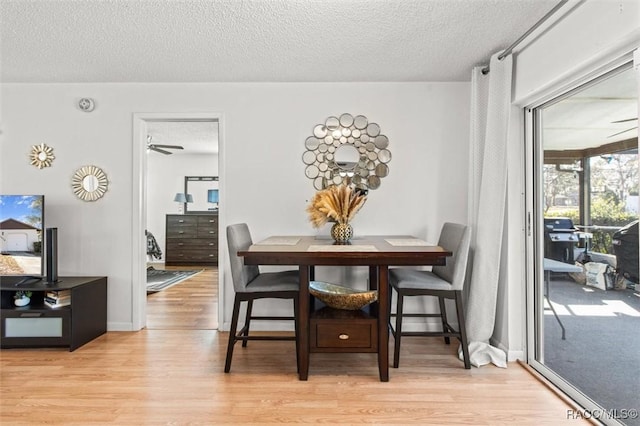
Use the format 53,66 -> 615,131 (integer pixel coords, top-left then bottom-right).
493,0 -> 640,359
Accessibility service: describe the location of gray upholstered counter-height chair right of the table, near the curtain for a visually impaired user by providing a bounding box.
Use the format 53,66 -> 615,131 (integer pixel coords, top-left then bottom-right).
389,223 -> 471,369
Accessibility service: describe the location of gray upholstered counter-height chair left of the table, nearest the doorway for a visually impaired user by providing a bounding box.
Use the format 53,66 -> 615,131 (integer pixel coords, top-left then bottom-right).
224,223 -> 300,373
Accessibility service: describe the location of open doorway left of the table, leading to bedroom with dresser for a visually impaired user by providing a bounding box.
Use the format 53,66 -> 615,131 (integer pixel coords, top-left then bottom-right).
134,114 -> 224,329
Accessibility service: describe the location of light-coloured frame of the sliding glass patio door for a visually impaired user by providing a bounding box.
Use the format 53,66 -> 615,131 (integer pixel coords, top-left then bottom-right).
523,52 -> 640,424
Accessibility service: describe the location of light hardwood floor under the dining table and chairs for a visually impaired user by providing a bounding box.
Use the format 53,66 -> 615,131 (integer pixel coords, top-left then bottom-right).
0,268 -> 589,425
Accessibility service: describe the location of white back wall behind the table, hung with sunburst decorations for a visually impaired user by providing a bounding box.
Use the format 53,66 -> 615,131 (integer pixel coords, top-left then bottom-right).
0,83 -> 470,330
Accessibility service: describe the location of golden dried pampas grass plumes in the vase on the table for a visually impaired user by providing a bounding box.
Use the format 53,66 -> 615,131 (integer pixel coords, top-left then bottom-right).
307,185 -> 367,228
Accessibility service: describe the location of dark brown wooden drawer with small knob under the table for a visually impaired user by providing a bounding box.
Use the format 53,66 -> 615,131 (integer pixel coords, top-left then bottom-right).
310,319 -> 378,352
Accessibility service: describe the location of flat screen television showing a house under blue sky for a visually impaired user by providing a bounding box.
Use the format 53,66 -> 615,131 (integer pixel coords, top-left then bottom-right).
0,194 -> 45,278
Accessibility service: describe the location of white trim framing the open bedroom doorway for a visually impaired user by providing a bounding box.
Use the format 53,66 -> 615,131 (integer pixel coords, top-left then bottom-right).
131,112 -> 226,331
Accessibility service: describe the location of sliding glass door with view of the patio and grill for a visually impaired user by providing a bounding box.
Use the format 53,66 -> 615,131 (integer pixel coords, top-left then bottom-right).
528,62 -> 640,425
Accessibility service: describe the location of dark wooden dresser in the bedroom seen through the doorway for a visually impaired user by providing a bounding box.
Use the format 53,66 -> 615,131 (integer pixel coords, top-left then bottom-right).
165,212 -> 218,266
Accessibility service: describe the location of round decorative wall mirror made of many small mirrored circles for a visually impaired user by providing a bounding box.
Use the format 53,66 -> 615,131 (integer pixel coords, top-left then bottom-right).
302,113 -> 391,190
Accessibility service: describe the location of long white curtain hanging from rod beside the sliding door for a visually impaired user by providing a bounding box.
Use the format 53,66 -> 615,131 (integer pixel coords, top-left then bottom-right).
460,53 -> 512,367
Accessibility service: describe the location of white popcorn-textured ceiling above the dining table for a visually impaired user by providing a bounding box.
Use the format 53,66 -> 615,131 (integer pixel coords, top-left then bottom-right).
0,0 -> 558,82
